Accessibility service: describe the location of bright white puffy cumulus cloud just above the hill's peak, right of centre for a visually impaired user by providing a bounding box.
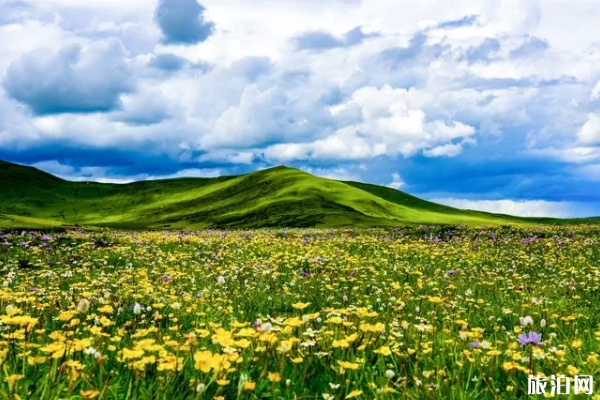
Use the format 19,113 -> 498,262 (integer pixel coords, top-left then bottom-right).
266,85 -> 475,160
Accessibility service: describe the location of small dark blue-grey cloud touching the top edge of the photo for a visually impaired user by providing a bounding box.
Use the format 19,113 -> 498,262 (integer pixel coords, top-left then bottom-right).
155,0 -> 215,45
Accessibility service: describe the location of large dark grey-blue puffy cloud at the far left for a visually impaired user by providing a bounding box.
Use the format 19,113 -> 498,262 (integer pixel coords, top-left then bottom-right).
4,38 -> 134,115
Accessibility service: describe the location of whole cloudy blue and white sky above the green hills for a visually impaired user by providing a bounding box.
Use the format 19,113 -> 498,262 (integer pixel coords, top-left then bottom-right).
0,0 -> 600,217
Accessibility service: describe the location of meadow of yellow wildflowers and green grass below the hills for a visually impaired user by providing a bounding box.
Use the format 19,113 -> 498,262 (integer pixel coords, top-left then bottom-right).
0,226 -> 600,400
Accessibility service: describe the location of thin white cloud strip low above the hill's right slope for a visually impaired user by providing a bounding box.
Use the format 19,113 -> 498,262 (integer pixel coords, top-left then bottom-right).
428,198 -> 597,218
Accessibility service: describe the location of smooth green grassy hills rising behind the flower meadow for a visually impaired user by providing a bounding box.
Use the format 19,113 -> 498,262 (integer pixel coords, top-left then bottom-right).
0,161 -> 596,229
